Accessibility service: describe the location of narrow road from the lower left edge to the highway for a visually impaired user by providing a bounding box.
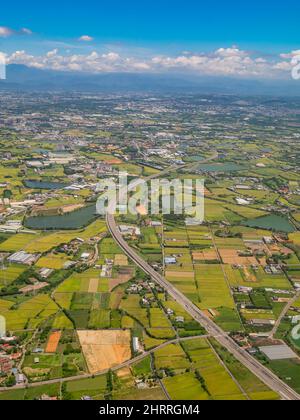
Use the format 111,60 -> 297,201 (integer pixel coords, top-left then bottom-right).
0,335 -> 209,393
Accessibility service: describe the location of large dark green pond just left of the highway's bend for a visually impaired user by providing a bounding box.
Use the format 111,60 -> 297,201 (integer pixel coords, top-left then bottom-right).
24,205 -> 97,230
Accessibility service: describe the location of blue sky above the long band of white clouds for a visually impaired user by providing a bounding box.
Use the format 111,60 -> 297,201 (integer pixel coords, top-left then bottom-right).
0,0 -> 300,78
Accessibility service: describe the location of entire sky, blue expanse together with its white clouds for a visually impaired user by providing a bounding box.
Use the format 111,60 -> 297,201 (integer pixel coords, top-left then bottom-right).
0,0 -> 300,79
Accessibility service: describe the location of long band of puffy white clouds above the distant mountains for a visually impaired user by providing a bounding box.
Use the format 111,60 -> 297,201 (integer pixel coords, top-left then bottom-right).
8,47 -> 300,78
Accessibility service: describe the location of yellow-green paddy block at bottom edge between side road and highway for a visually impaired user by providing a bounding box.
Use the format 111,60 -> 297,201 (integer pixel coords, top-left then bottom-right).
159,338 -> 278,400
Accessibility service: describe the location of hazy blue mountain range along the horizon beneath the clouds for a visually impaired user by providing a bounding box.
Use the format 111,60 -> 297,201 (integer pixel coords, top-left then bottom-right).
0,64 -> 300,96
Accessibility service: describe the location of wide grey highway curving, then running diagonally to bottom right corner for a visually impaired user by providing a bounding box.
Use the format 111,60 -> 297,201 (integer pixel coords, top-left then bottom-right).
106,153 -> 300,400
